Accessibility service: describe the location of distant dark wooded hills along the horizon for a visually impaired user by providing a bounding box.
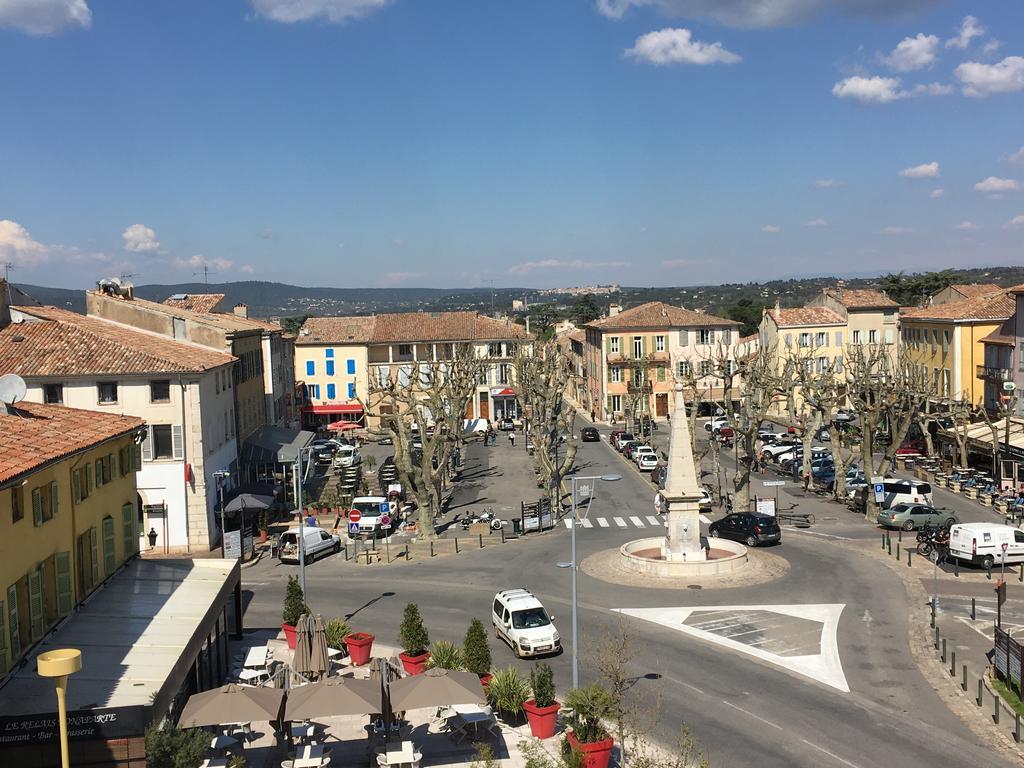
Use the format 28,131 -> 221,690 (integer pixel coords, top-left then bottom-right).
17,266 -> 1024,317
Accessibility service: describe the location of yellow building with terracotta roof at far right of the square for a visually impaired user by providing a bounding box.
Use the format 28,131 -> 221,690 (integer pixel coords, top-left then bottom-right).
901,291 -> 1015,404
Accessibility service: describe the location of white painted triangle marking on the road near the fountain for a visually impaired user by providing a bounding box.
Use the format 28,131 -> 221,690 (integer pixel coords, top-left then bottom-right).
614,603 -> 850,693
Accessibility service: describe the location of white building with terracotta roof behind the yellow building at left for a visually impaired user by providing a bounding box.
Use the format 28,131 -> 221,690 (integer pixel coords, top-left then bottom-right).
0,296 -> 238,552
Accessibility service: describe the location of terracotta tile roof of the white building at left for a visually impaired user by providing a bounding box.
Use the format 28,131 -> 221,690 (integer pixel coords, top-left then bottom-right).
0,306 -> 234,378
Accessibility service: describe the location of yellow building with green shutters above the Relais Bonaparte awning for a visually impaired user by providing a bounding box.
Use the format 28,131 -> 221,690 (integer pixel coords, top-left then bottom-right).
0,402 -> 144,673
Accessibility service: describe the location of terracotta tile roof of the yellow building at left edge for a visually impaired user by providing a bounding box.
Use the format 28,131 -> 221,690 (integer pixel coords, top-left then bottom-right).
0,402 -> 145,483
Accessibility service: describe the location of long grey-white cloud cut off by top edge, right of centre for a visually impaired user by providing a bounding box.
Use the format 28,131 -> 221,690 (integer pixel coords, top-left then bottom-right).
595,0 -> 939,28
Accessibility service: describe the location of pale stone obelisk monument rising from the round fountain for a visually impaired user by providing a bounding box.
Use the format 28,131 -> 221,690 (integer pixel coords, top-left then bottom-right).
660,384 -> 707,561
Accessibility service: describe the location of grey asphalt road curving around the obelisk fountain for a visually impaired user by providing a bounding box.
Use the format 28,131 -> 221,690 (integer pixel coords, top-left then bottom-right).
243,423 -> 998,768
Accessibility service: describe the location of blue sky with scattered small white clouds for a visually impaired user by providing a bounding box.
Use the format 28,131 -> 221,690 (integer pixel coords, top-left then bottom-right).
0,0 -> 1024,287
